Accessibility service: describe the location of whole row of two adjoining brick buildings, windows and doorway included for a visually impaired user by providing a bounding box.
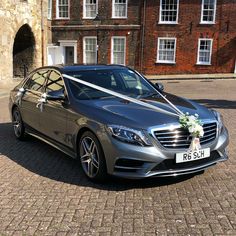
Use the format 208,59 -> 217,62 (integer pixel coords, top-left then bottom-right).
48,0 -> 236,74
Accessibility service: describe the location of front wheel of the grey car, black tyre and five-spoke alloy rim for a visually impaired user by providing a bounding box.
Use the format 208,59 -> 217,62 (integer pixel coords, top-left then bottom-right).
79,131 -> 107,181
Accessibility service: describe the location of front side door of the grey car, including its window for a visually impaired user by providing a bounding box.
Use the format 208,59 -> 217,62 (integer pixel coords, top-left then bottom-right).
40,70 -> 68,145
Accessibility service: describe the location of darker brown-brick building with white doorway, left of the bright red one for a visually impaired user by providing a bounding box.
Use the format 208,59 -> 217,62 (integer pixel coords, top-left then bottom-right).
48,0 -> 141,67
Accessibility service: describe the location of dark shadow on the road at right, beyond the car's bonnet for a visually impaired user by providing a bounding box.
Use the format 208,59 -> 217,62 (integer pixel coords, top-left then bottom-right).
193,99 -> 236,109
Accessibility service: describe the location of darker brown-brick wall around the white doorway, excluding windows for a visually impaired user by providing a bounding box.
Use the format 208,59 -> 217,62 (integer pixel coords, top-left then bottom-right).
52,0 -> 141,67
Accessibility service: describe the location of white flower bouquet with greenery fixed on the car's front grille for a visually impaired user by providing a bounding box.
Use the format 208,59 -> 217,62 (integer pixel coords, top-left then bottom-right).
179,113 -> 204,150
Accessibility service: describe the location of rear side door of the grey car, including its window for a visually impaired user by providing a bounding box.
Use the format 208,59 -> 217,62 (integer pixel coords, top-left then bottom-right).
20,69 -> 48,131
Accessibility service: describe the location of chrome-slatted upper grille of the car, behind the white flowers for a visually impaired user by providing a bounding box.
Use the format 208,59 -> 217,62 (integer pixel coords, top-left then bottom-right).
154,122 -> 217,149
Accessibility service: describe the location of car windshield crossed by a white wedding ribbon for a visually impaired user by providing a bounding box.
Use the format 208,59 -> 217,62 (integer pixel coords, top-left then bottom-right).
67,69 -> 157,100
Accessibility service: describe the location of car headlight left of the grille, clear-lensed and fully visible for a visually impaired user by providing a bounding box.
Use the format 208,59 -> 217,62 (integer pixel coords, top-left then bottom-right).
107,125 -> 152,146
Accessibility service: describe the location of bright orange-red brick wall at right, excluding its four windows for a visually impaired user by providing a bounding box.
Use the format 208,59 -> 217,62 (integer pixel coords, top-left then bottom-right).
143,0 -> 236,74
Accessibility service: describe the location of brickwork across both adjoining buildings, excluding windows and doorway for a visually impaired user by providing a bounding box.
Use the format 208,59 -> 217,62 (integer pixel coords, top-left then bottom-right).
48,0 -> 236,74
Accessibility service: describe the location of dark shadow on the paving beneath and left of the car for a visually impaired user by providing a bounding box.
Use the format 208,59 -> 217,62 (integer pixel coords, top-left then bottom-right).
0,123 -> 199,191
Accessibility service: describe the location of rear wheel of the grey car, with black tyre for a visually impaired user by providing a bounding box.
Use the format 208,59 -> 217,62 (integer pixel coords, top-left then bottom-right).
12,107 -> 25,140
